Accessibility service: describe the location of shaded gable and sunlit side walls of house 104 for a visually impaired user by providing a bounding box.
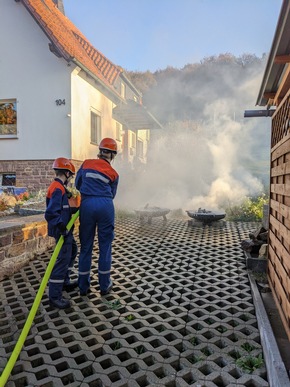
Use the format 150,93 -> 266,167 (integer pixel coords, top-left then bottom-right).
0,0 -> 121,161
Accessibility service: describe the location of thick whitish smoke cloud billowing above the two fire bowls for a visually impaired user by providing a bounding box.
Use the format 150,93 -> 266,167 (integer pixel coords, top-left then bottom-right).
115,60 -> 270,214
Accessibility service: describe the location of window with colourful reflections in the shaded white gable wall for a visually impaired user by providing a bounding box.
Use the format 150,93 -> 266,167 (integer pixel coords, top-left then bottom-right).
0,99 -> 17,136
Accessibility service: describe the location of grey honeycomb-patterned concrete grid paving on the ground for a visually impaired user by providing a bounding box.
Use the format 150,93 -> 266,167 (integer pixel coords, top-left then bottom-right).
0,218 -> 286,387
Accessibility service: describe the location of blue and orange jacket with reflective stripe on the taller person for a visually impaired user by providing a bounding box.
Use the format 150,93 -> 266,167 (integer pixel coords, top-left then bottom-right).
75,159 -> 119,199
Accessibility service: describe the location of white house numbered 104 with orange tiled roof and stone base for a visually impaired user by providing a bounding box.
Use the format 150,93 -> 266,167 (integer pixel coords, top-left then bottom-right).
0,0 -> 158,191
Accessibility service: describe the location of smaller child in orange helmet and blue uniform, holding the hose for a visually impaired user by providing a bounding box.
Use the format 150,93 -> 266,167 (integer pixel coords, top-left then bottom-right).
45,157 -> 78,309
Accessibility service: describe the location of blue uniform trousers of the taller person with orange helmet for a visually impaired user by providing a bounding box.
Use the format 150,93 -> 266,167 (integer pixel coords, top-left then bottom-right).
78,195 -> 115,292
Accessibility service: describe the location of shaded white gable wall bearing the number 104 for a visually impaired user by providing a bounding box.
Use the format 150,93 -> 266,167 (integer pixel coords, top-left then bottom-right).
0,0 -> 72,160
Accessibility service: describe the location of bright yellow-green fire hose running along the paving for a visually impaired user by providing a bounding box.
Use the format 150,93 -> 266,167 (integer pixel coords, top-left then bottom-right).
0,211 -> 79,387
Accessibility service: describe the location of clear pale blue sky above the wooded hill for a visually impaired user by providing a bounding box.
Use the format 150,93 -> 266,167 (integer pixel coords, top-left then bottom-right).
63,0 -> 282,72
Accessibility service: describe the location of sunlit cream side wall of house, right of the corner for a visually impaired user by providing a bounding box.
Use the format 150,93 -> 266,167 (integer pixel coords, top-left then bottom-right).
71,71 -> 116,160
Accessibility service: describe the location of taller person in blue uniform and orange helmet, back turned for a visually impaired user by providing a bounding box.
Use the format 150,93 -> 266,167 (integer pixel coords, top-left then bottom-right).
75,138 -> 119,296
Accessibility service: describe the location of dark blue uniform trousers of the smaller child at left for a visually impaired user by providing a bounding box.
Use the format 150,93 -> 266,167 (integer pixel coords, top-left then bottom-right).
49,233 -> 78,300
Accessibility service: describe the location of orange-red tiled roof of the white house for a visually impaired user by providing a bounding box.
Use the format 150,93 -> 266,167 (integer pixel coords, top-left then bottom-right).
21,0 -> 122,93
